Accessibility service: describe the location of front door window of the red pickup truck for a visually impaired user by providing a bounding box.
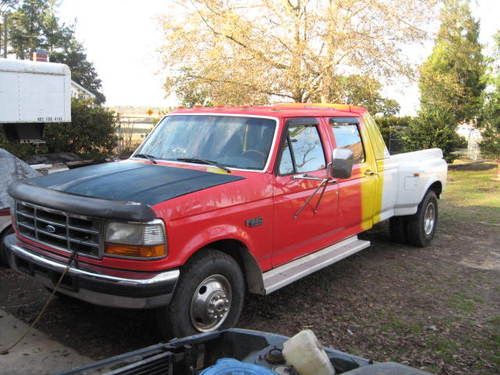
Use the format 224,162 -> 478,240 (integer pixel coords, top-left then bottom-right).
278,125 -> 326,175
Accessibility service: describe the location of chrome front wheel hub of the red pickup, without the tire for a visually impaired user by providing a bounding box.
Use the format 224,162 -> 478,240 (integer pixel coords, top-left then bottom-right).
189,274 -> 232,332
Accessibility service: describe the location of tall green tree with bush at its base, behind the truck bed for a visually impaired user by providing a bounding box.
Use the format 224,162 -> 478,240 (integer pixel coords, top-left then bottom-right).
402,0 -> 486,161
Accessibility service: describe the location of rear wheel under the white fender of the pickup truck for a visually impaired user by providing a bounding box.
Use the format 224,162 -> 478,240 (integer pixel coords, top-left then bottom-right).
407,190 -> 438,247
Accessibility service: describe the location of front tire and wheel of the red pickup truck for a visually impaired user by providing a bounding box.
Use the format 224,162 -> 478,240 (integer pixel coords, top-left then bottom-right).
156,249 -> 245,338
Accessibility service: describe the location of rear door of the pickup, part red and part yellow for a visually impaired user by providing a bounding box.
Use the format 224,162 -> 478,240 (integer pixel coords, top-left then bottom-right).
328,117 -> 377,237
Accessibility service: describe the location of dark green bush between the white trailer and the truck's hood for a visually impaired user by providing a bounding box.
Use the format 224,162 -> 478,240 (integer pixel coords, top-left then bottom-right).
45,99 -> 118,159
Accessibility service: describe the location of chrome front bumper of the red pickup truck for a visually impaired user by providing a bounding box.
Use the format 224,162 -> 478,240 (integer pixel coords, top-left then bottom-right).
4,234 -> 180,309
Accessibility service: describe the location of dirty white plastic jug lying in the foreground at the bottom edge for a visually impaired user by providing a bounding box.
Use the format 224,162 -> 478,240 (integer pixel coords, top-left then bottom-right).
283,329 -> 335,375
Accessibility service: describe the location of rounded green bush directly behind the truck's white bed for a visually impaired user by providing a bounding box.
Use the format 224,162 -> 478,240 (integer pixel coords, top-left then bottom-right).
402,111 -> 465,162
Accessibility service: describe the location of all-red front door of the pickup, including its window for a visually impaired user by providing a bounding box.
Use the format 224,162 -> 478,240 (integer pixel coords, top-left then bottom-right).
273,118 -> 337,266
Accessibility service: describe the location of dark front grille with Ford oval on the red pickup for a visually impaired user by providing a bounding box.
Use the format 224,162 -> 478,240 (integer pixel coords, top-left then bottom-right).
15,201 -> 102,257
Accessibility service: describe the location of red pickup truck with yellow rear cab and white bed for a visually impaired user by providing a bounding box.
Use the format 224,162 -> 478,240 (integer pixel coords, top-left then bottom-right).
5,104 -> 447,336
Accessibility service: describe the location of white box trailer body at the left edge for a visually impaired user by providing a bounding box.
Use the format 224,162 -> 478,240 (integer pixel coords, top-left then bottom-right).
0,59 -> 71,124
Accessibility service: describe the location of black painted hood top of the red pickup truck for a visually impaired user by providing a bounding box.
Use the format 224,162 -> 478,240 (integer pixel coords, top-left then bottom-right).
27,162 -> 243,206
